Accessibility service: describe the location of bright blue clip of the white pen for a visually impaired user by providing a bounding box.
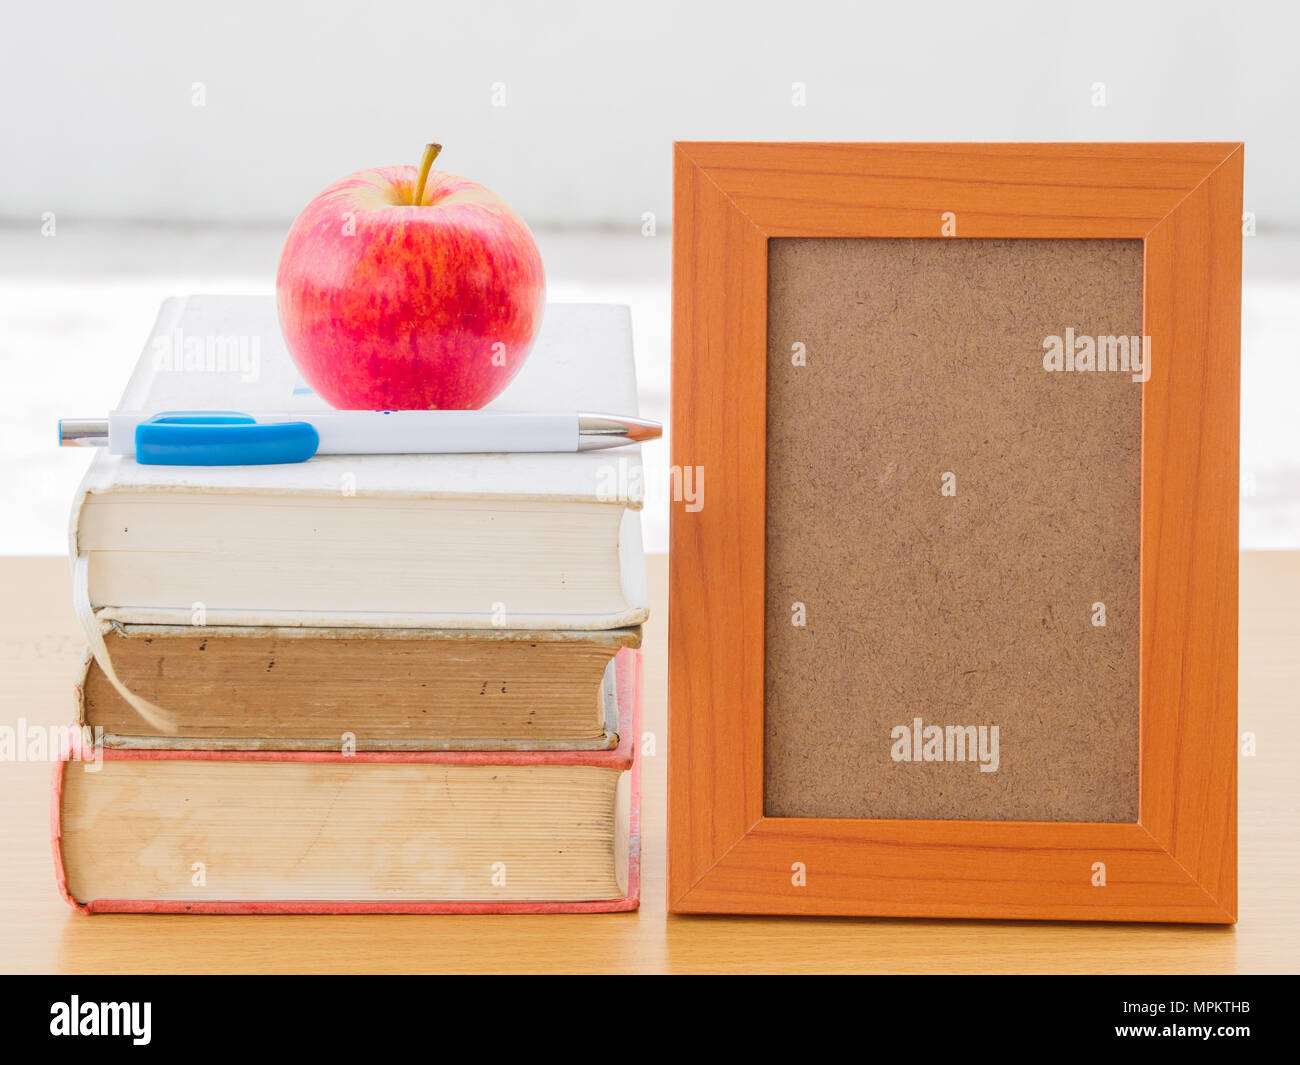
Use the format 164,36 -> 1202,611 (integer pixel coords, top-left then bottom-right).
135,411 -> 320,466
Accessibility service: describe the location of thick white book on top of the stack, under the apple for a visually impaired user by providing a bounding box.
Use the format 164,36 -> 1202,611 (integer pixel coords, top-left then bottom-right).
72,295 -> 647,631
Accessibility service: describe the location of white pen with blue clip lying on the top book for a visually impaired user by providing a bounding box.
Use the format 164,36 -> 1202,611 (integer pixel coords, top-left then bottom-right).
59,411 -> 663,466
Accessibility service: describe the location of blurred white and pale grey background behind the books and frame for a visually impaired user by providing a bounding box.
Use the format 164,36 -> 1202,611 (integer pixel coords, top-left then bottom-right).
0,0 -> 1300,553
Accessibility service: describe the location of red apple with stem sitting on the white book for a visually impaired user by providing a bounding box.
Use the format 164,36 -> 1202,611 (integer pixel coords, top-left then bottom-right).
276,144 -> 546,411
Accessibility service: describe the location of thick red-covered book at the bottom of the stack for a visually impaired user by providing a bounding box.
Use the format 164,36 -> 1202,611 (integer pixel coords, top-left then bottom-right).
52,648 -> 641,914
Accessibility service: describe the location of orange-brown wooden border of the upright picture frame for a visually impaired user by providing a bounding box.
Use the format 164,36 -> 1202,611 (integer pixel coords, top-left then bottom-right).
668,143 -> 1243,923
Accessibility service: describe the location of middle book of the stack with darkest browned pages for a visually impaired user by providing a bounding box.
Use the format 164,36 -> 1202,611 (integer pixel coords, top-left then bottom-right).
78,623 -> 641,750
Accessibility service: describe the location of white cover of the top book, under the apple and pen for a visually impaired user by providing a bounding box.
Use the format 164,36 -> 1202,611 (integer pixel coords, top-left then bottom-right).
82,295 -> 641,508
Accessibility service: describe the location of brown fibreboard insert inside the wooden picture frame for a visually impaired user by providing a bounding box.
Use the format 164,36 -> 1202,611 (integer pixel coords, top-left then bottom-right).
763,238 -> 1141,822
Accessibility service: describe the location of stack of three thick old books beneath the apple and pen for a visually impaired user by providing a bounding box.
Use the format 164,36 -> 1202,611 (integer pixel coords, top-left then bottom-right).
53,296 -> 647,913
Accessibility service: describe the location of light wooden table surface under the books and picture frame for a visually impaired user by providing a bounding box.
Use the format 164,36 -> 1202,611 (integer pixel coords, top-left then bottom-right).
0,553 -> 1300,973
